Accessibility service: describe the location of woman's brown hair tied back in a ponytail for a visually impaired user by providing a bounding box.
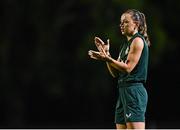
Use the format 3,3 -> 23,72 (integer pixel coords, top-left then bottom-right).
125,9 -> 150,46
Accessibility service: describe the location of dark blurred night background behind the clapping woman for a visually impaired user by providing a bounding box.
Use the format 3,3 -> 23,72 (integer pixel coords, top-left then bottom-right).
0,0 -> 180,128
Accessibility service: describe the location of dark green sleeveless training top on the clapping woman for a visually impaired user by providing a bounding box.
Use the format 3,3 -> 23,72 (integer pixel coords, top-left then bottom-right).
118,33 -> 149,83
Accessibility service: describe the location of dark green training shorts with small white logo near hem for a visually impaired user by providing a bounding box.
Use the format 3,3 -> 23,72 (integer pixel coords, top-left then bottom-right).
115,83 -> 148,124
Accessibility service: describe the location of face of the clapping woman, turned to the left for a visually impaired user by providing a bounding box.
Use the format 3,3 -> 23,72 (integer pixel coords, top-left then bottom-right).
120,13 -> 137,36
